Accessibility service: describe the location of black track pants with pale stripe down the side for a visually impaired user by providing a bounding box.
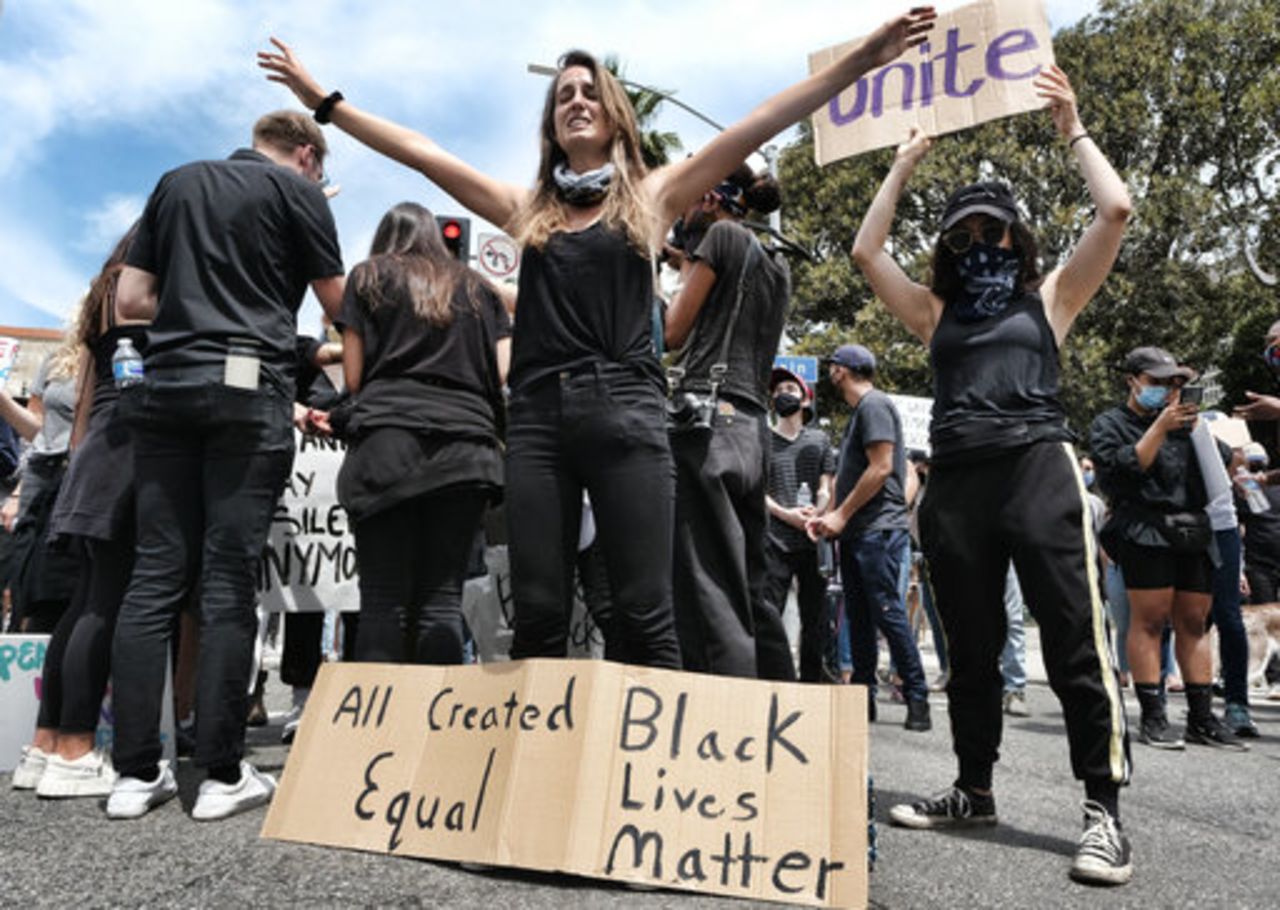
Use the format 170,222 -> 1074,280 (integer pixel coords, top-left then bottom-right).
920,443 -> 1129,788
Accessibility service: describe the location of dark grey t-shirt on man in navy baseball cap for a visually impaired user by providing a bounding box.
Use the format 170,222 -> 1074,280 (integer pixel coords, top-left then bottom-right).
833,389 -> 908,539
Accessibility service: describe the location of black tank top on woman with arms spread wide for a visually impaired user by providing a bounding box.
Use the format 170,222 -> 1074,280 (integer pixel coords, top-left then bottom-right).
511,221 -> 663,390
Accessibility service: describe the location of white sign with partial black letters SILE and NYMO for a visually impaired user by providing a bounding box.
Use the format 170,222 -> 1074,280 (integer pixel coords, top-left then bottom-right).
257,430 -> 360,613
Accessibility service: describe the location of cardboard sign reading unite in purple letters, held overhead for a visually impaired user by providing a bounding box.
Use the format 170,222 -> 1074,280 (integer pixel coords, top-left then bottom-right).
809,0 -> 1053,165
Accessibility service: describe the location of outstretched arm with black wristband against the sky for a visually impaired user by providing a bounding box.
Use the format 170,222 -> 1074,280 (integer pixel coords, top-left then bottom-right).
257,38 -> 529,228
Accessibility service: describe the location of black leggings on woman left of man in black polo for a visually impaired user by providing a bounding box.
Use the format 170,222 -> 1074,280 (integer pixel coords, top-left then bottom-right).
38,532 -> 133,733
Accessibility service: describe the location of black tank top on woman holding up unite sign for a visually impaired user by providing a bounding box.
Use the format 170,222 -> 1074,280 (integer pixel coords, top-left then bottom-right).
929,291 -> 1071,462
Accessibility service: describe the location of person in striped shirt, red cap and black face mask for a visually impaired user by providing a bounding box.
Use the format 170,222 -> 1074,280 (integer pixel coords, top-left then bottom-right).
764,367 -> 836,682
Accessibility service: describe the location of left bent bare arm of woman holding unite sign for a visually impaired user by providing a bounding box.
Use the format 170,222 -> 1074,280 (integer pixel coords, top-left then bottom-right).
852,127 -> 942,344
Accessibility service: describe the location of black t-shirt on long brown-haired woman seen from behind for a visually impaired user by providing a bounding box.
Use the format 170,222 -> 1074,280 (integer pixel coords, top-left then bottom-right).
342,262 -> 511,434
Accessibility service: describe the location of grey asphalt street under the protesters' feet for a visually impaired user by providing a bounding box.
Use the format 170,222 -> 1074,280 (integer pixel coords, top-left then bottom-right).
0,632 -> 1280,910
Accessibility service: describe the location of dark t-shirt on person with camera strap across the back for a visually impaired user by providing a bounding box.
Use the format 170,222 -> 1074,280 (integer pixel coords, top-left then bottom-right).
676,220 -> 791,408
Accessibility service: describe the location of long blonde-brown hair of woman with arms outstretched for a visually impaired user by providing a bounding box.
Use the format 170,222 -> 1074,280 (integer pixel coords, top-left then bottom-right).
511,50 -> 657,256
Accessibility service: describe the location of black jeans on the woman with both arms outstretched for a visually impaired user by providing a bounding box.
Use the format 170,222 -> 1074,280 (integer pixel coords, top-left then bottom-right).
507,366 -> 680,668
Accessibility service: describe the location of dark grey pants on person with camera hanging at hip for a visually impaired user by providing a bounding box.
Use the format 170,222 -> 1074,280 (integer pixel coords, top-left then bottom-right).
671,402 -> 796,680
